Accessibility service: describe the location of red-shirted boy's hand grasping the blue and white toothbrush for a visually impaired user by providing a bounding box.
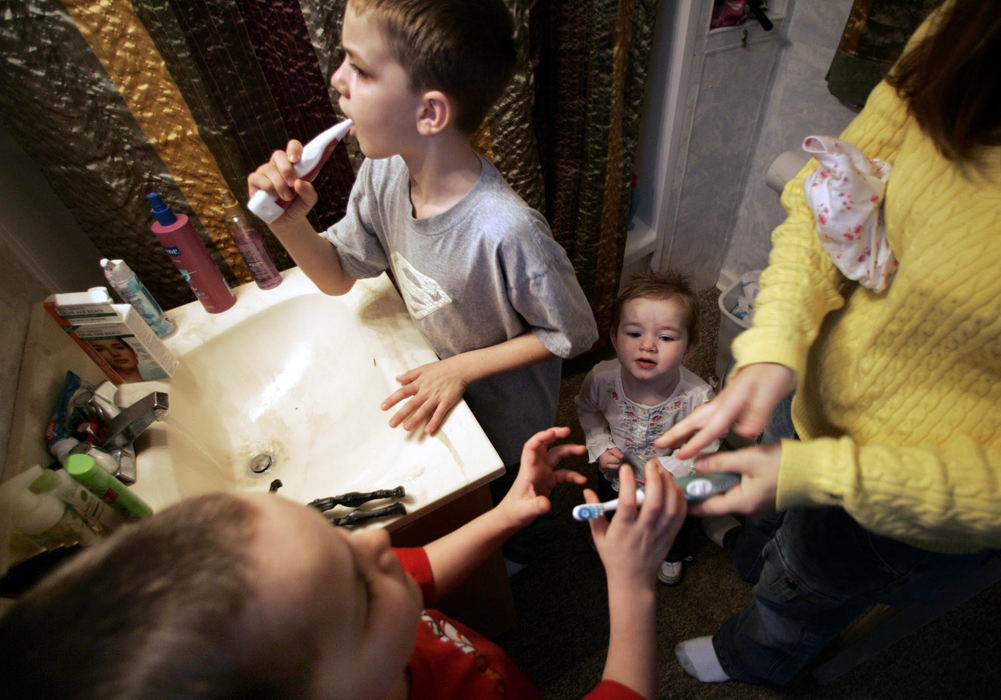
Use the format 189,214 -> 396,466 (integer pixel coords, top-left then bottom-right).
584,465 -> 688,590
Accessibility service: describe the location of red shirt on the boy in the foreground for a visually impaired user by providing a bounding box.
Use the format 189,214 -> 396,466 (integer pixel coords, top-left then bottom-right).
394,548 -> 642,700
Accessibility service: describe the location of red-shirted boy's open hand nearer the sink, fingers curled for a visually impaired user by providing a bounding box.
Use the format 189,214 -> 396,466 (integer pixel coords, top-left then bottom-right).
497,428 -> 588,528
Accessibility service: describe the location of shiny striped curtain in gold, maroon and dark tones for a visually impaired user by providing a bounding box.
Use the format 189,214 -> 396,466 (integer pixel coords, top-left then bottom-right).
0,0 -> 656,334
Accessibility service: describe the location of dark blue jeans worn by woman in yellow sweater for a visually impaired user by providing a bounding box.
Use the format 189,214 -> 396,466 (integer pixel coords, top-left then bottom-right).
713,508 -> 996,685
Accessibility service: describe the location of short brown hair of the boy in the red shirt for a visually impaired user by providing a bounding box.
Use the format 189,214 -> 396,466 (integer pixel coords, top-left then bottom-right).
0,494 -> 315,698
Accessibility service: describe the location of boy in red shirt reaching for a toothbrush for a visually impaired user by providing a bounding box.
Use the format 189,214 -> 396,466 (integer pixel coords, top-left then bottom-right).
0,428 -> 687,698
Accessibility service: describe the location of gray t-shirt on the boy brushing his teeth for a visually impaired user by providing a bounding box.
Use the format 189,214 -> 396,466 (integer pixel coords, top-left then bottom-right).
321,156 -> 598,465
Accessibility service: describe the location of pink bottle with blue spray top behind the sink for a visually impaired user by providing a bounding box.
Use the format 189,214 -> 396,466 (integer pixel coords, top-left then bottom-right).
146,192 -> 236,313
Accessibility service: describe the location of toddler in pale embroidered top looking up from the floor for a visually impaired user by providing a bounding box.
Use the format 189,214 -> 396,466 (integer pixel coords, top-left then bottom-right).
576,273 -> 719,585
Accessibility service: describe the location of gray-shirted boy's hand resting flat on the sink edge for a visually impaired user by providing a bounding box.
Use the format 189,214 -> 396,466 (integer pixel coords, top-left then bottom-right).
380,356 -> 468,435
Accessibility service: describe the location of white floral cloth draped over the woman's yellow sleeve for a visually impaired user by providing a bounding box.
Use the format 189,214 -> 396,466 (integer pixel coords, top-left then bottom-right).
803,136 -> 897,291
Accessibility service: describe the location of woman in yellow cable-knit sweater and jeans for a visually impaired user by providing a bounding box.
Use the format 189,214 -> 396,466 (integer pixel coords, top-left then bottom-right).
655,0 -> 1001,684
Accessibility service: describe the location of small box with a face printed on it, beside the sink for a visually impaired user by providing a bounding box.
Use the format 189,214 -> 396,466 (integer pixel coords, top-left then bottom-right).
43,286 -> 177,384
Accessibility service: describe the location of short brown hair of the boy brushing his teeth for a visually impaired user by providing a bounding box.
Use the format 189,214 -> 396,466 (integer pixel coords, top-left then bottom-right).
349,0 -> 516,134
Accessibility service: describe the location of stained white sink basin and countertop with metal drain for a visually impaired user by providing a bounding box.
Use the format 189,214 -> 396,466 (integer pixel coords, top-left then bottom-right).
119,268 -> 503,529
